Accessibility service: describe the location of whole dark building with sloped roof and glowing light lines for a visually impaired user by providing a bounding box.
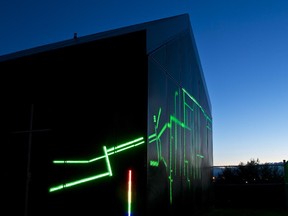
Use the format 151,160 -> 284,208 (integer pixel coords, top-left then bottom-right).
0,14 -> 213,216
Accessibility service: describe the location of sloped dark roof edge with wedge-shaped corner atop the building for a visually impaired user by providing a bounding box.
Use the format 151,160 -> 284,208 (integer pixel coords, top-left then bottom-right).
0,14 -> 191,62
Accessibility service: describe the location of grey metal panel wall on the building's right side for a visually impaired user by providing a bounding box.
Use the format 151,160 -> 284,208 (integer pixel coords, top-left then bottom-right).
147,28 -> 213,215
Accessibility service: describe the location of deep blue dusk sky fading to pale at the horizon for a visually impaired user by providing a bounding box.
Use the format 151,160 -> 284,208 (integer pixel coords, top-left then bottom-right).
0,0 -> 288,165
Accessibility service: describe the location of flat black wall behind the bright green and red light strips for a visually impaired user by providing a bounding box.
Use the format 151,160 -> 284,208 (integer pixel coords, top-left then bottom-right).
0,31 -> 147,216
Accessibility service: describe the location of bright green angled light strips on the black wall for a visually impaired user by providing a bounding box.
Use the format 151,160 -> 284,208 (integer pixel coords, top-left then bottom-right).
49,137 -> 145,192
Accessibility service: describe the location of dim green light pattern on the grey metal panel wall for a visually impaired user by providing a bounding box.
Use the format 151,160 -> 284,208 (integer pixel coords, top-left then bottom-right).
148,88 -> 212,203
